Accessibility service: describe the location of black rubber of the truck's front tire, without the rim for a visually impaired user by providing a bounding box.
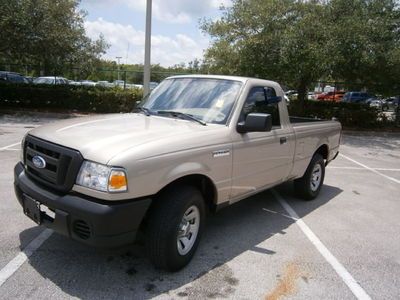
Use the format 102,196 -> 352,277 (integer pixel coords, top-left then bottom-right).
146,186 -> 205,272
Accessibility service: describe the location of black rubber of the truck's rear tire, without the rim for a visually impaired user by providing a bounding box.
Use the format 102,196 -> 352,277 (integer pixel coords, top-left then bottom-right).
294,153 -> 325,200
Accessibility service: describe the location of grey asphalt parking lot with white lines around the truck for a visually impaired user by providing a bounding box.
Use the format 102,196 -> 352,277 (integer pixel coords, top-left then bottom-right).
0,115 -> 400,299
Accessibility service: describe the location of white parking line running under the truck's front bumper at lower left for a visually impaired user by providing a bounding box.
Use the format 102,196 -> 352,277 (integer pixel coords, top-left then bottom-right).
0,229 -> 53,287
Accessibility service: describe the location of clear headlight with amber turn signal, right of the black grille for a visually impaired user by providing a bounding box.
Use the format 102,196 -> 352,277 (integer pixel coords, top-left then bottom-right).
76,161 -> 128,193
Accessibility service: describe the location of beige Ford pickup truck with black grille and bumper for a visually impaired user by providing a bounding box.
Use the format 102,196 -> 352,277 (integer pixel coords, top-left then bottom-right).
15,75 -> 341,271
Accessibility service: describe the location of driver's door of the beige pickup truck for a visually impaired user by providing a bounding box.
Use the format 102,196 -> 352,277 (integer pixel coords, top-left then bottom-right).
231,86 -> 293,202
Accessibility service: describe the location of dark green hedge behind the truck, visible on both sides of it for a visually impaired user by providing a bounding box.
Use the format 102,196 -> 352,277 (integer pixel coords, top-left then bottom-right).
0,82 -> 395,129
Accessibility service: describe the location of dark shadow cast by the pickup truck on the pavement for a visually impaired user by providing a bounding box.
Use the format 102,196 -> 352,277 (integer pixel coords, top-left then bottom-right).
20,183 -> 342,299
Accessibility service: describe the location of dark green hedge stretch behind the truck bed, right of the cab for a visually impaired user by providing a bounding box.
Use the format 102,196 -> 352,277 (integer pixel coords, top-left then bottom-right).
289,101 -> 395,129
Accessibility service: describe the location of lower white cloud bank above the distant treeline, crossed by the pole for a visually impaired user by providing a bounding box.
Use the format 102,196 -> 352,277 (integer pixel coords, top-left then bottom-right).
85,18 -> 208,66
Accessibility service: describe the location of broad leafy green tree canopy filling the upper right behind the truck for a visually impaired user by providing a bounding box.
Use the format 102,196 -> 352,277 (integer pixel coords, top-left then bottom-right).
201,0 -> 400,101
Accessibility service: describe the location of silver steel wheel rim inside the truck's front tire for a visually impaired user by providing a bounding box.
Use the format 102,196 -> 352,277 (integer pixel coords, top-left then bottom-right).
177,205 -> 200,255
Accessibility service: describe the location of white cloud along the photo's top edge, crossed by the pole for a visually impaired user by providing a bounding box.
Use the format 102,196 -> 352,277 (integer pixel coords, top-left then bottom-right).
86,0 -> 232,24
